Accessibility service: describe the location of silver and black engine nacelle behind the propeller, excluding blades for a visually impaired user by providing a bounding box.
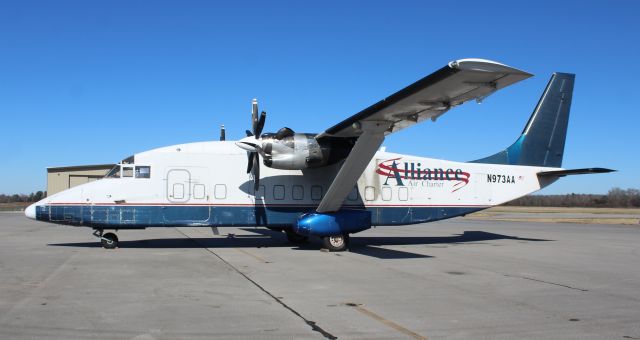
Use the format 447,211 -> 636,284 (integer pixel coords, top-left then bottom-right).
260,128 -> 353,170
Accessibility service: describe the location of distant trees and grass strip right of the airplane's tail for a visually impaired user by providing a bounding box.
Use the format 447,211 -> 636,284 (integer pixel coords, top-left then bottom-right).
504,188 -> 640,208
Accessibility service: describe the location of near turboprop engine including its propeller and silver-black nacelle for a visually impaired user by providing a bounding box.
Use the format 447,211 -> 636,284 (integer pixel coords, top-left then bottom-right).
236,99 -> 355,188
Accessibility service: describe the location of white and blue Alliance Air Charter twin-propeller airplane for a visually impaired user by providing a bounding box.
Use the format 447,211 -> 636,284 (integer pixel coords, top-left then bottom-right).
25,59 -> 613,251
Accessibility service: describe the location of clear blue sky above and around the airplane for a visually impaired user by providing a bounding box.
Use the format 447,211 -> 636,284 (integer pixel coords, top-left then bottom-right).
0,1 -> 640,194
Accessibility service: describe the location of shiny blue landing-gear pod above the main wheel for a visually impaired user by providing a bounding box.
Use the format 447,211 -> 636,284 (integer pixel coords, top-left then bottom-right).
293,210 -> 371,236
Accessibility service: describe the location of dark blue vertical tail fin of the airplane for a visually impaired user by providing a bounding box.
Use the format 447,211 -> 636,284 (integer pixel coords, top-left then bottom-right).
472,73 -> 575,167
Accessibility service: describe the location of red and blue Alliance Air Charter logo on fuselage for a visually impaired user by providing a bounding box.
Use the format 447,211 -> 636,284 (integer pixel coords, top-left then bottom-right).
376,157 -> 471,192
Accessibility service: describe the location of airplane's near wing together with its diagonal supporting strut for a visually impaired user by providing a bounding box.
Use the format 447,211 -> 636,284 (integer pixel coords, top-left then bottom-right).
316,59 -> 531,212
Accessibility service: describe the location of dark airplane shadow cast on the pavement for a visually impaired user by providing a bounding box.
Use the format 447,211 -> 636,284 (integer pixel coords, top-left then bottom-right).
48,228 -> 552,259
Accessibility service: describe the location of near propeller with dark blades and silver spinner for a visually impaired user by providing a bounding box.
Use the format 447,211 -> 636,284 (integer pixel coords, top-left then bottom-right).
236,99 -> 267,192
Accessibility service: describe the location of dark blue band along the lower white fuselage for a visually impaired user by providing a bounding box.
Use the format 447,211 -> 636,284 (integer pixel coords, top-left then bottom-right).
36,205 -> 486,229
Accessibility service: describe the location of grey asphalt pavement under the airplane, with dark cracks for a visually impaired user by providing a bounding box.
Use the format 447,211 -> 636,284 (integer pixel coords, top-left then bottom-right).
0,213 -> 640,339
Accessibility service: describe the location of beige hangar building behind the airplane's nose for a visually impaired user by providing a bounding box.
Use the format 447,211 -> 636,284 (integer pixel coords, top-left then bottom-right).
47,164 -> 115,196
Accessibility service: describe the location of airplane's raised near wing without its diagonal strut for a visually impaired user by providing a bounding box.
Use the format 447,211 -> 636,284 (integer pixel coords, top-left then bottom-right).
316,59 -> 532,138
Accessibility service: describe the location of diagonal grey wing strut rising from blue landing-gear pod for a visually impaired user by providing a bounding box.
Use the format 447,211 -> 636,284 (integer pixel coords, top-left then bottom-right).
317,121 -> 393,212
